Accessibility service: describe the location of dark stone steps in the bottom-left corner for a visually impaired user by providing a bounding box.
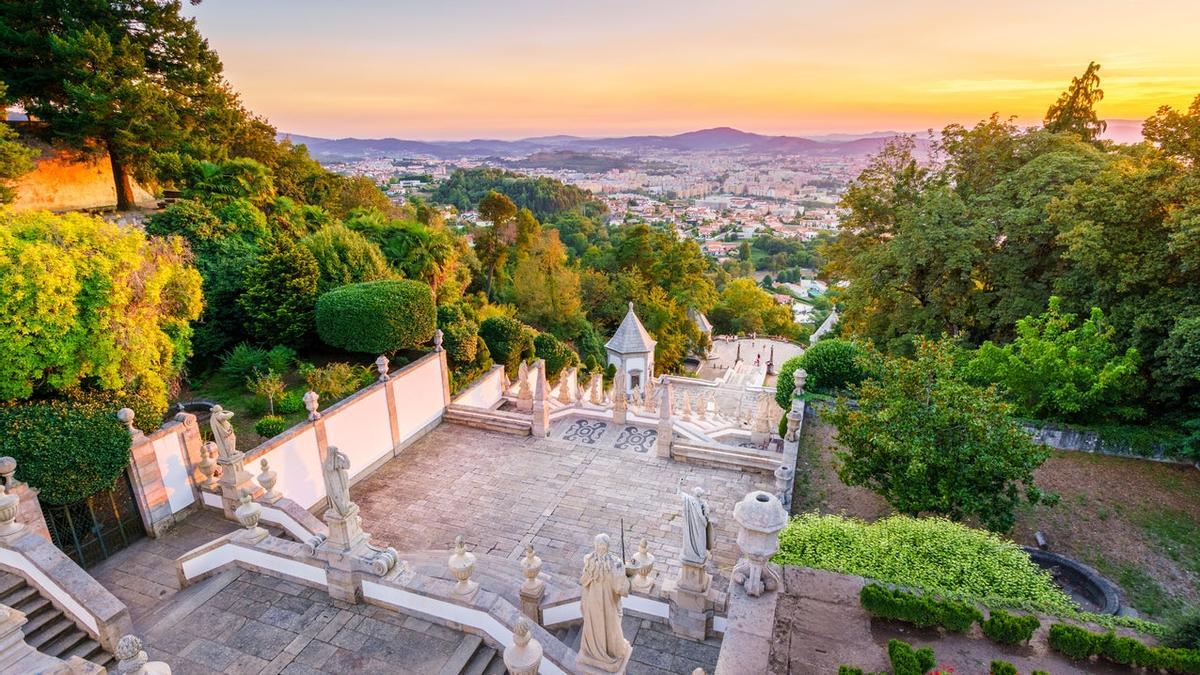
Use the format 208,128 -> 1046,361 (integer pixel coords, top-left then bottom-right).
0,572 -> 116,670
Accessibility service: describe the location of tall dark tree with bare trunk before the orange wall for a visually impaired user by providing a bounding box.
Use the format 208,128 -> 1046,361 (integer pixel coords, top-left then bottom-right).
0,0 -> 226,209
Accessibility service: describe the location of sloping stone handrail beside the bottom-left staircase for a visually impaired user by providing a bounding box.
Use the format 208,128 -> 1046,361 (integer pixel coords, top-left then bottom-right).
0,528 -> 133,651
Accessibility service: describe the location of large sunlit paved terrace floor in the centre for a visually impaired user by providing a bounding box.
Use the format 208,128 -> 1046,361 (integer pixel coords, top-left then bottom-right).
350,424 -> 774,589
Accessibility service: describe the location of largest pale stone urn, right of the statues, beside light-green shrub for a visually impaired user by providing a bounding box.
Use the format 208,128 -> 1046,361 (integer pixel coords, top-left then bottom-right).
732,490 -> 787,596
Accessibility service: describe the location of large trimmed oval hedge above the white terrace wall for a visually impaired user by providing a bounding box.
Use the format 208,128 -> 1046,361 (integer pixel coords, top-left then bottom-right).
317,279 -> 437,354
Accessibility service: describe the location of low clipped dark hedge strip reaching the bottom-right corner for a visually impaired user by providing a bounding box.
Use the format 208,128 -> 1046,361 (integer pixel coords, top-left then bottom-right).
1048,623 -> 1200,675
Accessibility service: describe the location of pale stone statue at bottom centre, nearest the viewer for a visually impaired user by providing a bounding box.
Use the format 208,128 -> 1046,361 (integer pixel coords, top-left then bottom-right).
576,534 -> 632,673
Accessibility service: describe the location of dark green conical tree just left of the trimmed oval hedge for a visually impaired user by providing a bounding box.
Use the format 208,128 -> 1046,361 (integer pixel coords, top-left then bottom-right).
238,237 -> 320,347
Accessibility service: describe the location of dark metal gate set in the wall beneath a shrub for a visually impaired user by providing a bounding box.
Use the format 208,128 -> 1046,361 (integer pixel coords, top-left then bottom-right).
42,472 -> 146,568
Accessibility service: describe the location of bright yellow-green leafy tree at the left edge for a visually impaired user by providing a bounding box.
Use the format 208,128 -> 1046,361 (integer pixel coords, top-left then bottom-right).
0,210 -> 202,413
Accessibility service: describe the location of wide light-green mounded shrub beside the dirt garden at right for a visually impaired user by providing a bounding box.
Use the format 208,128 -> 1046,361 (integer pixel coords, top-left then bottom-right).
774,514 -> 1078,613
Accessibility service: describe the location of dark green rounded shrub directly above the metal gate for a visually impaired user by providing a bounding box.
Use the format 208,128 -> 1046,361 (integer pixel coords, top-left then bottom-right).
0,396 -> 132,504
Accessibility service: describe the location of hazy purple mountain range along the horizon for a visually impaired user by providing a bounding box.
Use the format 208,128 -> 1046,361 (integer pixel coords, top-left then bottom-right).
280,126 -> 924,160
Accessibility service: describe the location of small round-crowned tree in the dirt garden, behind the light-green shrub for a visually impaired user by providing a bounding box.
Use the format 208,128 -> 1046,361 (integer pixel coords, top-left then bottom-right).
828,339 -> 1050,532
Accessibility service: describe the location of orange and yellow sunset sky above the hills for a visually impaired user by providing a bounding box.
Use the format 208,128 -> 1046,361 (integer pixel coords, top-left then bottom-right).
185,0 -> 1200,139
